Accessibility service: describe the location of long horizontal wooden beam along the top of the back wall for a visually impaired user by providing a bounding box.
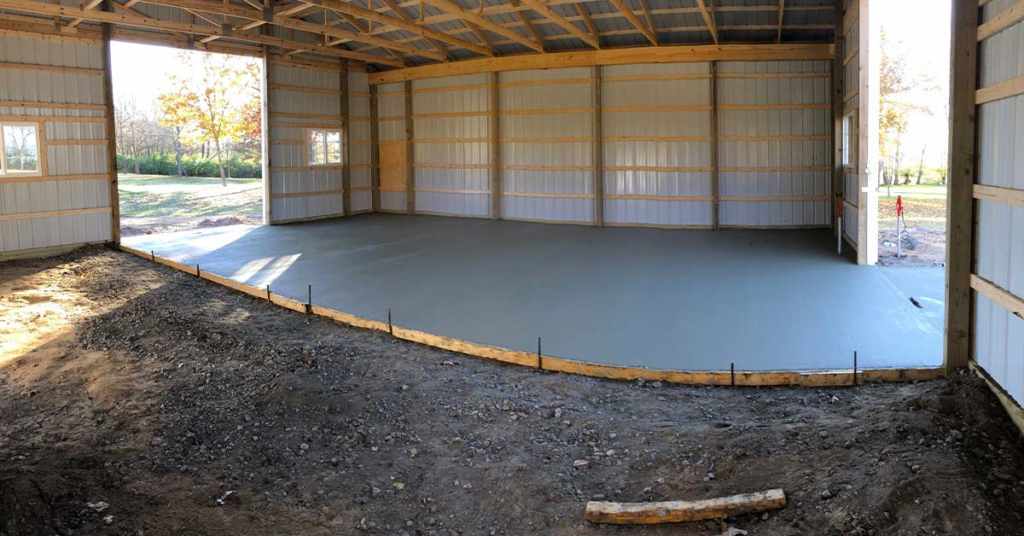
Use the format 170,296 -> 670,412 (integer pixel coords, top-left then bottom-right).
370,44 -> 835,84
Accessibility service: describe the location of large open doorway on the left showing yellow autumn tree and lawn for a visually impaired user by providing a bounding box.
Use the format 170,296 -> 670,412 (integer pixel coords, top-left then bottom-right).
112,42 -> 263,236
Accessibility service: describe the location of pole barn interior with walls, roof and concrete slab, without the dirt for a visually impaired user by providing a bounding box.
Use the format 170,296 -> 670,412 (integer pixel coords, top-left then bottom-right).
0,0 -> 1024,420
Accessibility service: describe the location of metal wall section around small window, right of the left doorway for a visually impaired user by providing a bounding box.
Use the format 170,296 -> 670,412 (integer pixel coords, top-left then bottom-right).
268,61 -> 344,223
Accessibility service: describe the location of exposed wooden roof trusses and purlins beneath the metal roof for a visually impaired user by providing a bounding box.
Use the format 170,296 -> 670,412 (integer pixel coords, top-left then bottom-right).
0,0 -> 836,71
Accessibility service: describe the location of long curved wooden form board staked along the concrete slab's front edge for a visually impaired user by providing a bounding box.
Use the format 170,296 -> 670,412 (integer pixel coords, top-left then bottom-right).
119,245 -> 945,387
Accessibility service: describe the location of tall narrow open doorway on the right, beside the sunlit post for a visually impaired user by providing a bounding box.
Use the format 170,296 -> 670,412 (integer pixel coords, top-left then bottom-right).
877,0 -> 951,266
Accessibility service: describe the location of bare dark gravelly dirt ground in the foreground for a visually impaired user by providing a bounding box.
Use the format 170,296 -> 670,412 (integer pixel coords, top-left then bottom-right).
0,249 -> 1024,536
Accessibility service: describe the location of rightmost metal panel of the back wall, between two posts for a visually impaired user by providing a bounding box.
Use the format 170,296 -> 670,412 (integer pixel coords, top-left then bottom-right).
718,61 -> 831,228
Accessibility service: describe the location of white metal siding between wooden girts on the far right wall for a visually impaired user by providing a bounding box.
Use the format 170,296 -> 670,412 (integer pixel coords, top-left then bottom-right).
974,4 -> 1024,404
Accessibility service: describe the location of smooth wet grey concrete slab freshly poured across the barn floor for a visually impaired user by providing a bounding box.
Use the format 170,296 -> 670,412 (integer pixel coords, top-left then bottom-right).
124,214 -> 943,370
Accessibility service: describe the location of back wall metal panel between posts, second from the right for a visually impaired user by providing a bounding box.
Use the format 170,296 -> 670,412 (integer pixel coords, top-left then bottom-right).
601,64 -> 712,226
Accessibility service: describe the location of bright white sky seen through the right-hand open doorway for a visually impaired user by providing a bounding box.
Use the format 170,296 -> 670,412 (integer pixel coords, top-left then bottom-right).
871,0 -> 951,167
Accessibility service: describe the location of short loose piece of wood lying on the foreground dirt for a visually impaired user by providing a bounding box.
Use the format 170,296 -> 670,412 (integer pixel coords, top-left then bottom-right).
584,490 -> 785,525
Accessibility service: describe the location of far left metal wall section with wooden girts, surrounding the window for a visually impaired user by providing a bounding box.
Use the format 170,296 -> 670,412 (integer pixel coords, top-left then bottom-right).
0,32 -> 114,255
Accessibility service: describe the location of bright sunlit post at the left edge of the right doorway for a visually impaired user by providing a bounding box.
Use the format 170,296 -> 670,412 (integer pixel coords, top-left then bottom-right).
857,0 -> 882,265
